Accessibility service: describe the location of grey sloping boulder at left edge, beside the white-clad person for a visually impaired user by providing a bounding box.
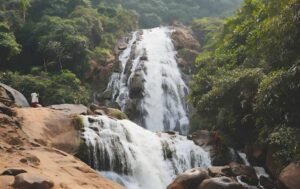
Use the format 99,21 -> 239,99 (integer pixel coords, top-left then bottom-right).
0,83 -> 29,107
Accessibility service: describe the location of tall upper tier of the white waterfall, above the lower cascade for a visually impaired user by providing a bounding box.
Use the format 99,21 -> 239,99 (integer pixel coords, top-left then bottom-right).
107,27 -> 189,134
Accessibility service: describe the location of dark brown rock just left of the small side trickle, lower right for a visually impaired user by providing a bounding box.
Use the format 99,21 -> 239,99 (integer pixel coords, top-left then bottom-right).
229,163 -> 258,185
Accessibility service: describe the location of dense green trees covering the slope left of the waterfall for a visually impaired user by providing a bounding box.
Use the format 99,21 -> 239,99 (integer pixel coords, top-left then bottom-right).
0,0 -> 137,105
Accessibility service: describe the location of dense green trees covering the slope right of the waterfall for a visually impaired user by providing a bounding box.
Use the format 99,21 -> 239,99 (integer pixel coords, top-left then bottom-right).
191,0 -> 300,168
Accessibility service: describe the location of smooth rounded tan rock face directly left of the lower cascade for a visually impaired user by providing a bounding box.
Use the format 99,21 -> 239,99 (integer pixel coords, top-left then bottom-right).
15,108 -> 81,154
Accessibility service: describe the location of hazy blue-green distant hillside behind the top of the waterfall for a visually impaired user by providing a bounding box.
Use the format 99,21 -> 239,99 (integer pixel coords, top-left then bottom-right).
99,0 -> 242,28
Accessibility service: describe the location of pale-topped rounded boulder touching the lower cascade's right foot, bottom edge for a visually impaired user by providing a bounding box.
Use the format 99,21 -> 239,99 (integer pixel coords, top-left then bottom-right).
167,168 -> 209,189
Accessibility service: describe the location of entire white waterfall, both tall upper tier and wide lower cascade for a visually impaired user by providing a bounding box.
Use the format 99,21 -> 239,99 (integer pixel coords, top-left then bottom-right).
82,27 -> 211,189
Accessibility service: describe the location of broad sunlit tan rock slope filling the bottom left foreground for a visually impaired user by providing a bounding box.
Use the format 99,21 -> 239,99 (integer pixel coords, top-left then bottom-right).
0,108 -> 122,189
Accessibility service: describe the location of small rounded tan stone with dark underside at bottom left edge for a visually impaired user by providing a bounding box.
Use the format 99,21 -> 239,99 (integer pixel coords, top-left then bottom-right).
13,173 -> 54,189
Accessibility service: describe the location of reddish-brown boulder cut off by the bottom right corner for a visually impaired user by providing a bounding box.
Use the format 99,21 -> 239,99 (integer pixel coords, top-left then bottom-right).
279,162 -> 300,189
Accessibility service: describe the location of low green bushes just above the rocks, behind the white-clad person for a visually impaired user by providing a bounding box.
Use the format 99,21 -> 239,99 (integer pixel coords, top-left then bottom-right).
0,71 -> 91,106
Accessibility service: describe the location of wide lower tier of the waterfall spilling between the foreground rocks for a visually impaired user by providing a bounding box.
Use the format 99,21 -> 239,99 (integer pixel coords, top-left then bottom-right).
82,116 -> 210,189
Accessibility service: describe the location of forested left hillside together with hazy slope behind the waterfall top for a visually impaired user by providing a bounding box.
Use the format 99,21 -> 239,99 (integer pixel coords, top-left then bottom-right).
0,0 -> 240,105
